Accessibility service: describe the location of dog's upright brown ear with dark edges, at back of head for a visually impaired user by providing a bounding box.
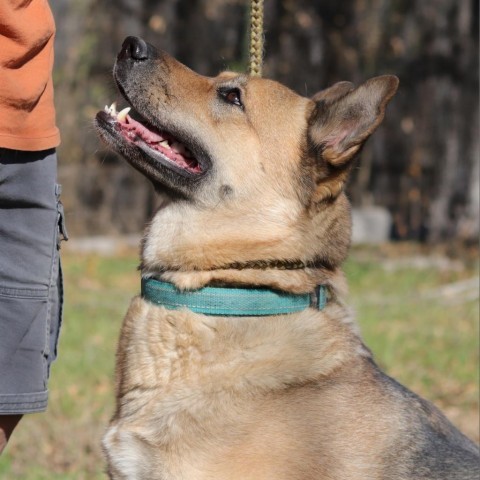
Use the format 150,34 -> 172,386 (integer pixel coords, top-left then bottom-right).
308,75 -> 398,166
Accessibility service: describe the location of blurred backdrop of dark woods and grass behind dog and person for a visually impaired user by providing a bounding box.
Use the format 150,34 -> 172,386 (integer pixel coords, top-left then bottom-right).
0,0 -> 480,480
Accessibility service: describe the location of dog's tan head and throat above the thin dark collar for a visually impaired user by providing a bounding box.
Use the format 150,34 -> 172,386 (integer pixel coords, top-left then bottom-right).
96,37 -> 398,284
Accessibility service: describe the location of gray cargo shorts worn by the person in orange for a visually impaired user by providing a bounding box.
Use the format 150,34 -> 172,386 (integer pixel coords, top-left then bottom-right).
0,148 -> 66,415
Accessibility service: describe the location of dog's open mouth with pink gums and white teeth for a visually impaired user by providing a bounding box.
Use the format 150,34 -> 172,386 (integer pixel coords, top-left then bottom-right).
100,103 -> 202,175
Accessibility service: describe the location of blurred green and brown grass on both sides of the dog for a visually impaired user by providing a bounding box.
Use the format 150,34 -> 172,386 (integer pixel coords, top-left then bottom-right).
0,246 -> 479,480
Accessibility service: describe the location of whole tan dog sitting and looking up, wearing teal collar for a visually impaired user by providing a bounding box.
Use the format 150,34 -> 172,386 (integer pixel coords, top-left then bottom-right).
95,37 -> 479,480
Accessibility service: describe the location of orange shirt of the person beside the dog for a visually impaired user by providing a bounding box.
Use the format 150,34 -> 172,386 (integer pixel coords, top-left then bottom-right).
0,0 -> 60,151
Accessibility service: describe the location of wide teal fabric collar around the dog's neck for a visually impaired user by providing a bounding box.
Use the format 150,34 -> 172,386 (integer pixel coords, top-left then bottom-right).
142,278 -> 327,317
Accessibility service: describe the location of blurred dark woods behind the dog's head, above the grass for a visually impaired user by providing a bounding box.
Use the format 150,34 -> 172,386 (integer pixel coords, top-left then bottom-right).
52,0 -> 480,243
